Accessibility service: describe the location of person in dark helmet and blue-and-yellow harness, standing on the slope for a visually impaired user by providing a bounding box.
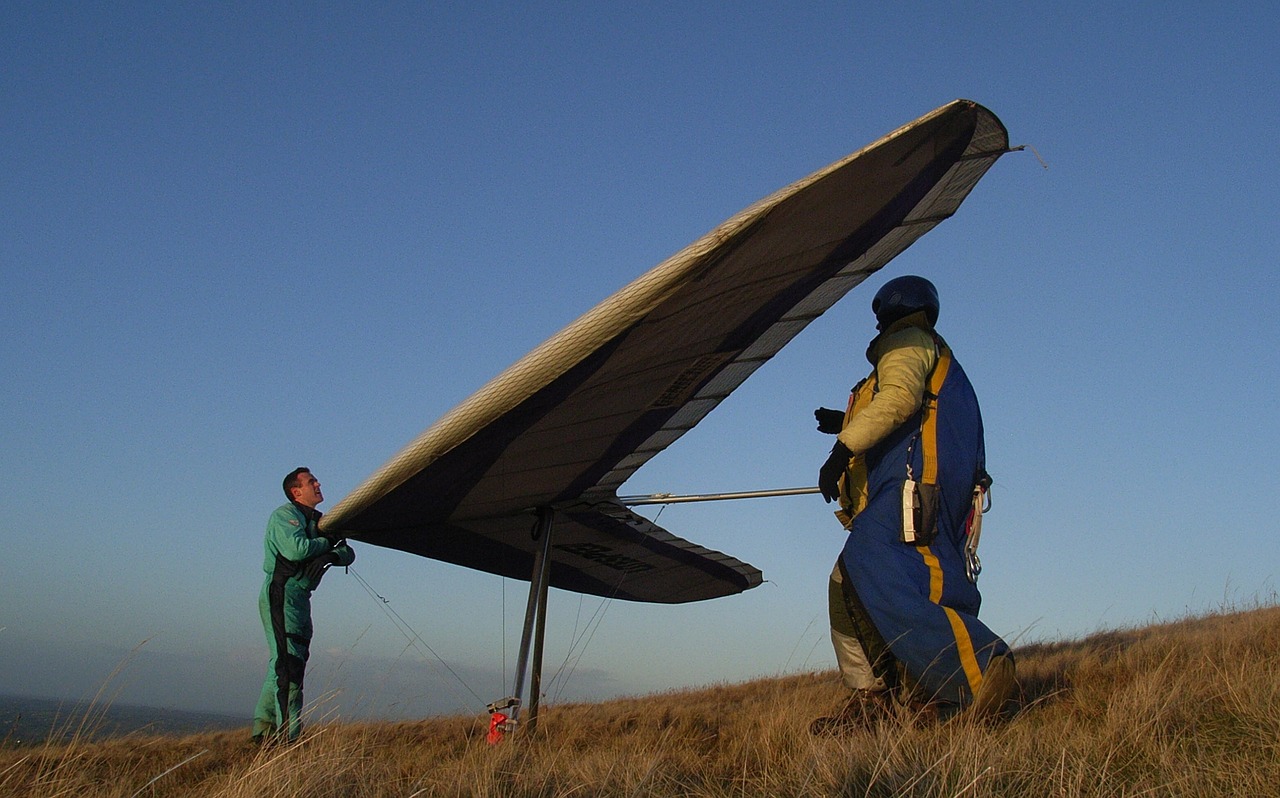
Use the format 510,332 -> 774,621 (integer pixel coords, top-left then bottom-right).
812,277 -> 1015,733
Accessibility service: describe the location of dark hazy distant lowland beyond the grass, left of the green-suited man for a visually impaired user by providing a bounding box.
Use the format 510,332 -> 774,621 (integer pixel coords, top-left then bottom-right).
0,694 -> 240,745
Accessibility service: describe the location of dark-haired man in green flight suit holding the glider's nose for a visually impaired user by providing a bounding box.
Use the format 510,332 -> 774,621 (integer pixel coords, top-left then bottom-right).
253,468 -> 356,743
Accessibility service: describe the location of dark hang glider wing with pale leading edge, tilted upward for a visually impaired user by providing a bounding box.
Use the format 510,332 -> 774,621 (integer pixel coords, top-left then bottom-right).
323,100 -> 1009,604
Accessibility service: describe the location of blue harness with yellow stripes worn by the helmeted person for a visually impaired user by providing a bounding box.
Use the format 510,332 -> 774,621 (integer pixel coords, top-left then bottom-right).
833,321 -> 1009,706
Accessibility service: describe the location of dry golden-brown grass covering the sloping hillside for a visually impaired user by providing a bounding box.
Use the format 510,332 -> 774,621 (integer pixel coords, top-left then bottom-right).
0,607 -> 1280,798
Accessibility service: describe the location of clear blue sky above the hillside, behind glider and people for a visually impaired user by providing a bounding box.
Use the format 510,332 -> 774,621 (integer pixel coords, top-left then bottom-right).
0,1 -> 1280,717
